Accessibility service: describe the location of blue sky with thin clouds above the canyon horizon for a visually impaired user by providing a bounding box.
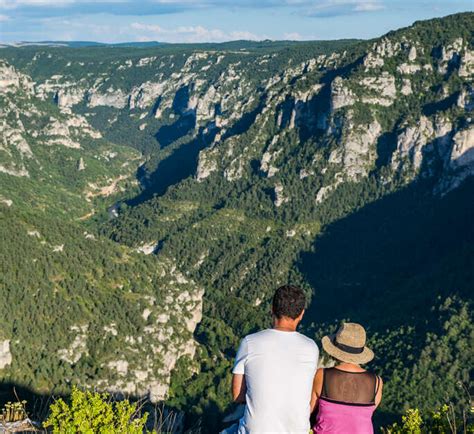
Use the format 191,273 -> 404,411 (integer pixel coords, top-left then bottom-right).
0,0 -> 474,42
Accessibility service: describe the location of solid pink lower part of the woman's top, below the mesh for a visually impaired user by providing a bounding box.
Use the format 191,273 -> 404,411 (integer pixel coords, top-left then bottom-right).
313,398 -> 375,434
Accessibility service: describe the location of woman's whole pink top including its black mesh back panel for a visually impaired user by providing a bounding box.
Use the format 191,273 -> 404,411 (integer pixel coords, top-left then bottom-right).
314,368 -> 379,434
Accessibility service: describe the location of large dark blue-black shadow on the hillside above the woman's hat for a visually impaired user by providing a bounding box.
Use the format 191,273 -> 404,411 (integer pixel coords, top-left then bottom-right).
298,179 -> 474,332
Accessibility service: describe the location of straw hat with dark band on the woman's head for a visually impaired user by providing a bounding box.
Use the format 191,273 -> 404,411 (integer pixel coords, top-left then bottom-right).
322,322 -> 374,364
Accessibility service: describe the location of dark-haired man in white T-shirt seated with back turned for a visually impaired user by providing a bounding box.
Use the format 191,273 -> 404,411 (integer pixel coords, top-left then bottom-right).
232,286 -> 319,434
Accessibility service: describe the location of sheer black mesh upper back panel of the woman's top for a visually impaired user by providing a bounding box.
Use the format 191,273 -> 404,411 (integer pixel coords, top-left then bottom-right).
321,368 -> 380,405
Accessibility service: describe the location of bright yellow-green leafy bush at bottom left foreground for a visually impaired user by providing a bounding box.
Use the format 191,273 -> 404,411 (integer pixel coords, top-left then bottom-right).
44,388 -> 148,434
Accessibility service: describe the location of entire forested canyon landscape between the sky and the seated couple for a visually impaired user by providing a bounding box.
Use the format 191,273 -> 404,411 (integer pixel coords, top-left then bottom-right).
0,13 -> 474,431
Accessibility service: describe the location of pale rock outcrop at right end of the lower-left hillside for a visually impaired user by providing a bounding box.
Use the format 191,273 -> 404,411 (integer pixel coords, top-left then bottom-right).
99,267 -> 204,402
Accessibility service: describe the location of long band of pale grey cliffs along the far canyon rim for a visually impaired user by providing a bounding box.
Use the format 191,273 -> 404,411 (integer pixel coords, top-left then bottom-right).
3,22 -> 473,204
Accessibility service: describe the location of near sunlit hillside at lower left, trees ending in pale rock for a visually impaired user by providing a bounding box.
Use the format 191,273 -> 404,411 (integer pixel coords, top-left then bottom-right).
0,203 -> 204,402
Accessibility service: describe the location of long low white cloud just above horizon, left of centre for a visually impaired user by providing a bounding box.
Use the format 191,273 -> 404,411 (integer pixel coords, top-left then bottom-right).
131,22 -> 265,42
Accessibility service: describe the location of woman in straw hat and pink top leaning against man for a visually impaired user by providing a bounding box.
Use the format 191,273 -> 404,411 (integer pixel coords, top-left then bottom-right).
311,323 -> 383,434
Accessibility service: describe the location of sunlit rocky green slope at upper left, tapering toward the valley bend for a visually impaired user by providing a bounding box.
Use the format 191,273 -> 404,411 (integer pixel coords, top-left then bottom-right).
0,60 -> 140,220
